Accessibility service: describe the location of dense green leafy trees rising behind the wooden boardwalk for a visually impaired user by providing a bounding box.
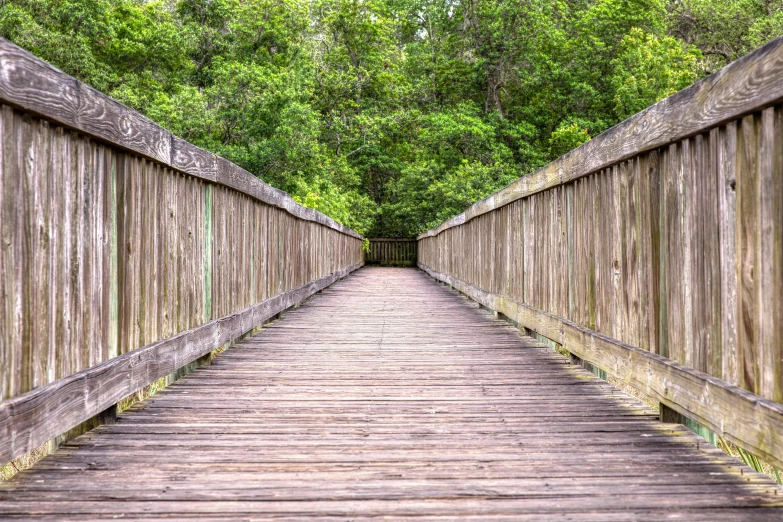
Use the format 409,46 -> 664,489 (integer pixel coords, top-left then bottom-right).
0,0 -> 783,232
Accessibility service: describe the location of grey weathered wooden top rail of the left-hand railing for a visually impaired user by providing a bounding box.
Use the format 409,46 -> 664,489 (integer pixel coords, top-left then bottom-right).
0,38 -> 361,239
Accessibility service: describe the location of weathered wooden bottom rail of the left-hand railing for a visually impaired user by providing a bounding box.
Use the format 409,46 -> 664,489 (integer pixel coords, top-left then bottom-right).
0,264 -> 361,462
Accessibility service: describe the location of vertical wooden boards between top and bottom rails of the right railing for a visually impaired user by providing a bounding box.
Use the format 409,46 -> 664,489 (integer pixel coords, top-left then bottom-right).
419,100 -> 783,410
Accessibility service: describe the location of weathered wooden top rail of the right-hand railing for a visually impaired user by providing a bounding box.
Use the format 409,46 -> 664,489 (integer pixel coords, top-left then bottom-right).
418,38 -> 783,239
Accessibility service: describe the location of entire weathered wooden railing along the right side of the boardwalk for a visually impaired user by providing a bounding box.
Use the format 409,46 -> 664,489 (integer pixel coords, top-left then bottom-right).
419,39 -> 783,467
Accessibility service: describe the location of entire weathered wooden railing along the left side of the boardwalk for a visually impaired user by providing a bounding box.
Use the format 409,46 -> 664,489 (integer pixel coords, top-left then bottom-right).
0,39 -> 362,463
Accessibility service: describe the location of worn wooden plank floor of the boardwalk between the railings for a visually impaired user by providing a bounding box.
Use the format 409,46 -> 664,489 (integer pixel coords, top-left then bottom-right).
0,268 -> 783,521
